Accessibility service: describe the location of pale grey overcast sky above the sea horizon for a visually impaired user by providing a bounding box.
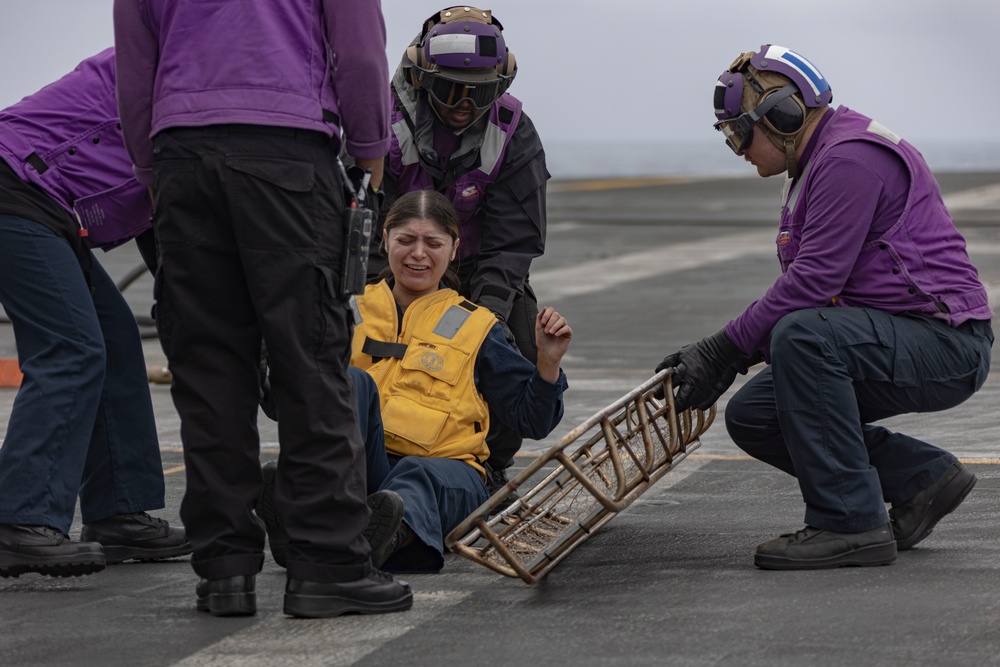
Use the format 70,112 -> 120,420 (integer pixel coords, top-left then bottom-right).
0,0 -> 1000,147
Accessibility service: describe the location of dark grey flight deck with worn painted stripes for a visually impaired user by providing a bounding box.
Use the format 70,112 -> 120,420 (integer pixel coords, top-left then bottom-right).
0,173 -> 1000,667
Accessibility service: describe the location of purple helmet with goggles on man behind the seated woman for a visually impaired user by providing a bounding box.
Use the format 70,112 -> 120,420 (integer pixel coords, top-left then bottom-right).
406,7 -> 517,109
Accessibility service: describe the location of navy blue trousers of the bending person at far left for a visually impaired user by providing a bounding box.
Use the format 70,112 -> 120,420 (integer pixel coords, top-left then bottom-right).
0,215 -> 164,533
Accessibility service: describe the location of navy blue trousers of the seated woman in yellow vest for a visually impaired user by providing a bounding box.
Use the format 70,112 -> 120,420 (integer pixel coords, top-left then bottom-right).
350,366 -> 489,572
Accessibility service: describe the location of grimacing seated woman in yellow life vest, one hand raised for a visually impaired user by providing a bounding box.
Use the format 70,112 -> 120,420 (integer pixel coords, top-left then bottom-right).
351,190 -> 573,572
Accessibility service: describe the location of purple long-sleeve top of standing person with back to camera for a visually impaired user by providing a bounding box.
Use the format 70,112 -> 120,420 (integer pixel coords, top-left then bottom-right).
114,0 -> 390,184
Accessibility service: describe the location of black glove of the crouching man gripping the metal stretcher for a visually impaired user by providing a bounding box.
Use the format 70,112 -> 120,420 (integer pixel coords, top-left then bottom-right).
656,329 -> 748,411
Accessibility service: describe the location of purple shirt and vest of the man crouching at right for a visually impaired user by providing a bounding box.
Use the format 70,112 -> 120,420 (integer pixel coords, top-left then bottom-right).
726,107 -> 993,356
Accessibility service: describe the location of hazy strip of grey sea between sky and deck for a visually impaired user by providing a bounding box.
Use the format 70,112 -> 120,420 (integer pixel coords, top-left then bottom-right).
543,139 -> 1000,180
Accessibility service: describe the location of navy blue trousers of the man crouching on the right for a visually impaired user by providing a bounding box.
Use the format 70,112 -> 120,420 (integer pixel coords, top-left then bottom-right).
726,308 -> 993,532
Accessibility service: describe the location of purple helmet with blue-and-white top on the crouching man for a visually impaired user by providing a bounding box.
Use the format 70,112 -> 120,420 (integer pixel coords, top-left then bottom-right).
713,44 -> 833,176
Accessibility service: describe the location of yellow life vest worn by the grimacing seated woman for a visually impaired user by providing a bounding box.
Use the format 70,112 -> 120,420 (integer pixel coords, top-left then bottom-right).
351,280 -> 496,474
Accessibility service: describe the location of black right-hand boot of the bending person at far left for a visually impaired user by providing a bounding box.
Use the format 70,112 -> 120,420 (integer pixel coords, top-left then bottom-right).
80,512 -> 193,565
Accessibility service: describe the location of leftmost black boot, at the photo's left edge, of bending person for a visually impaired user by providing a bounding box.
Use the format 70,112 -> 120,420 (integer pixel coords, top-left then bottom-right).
0,524 -> 105,577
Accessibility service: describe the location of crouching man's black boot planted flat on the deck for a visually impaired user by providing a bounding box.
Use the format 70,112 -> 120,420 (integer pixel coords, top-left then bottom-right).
753,523 -> 896,570
